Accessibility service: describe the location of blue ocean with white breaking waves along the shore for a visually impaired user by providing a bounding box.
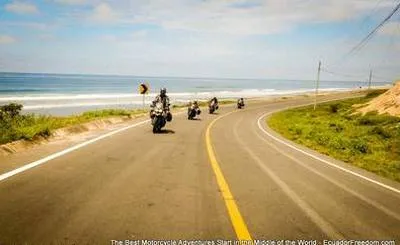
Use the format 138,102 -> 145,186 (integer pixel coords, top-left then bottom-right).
0,73 -> 390,115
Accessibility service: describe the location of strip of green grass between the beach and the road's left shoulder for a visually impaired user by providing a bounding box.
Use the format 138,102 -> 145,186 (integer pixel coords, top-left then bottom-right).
0,109 -> 144,144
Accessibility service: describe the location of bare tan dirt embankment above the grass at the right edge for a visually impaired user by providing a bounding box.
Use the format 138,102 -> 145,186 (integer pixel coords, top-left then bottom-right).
358,81 -> 400,116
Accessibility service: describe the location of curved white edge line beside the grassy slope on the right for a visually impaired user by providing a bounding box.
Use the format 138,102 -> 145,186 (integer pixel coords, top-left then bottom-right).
257,101 -> 400,194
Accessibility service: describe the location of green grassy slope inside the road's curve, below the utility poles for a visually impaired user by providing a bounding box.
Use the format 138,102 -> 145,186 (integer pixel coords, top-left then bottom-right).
267,90 -> 400,182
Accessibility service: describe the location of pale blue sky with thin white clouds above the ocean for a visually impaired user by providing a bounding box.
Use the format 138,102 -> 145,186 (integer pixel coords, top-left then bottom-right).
0,0 -> 400,81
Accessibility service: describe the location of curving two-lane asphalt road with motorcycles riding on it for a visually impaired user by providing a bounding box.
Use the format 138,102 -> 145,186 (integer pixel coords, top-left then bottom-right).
0,95 -> 400,244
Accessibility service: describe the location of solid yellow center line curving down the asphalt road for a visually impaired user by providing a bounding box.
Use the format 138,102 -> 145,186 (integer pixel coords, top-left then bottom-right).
206,112 -> 252,241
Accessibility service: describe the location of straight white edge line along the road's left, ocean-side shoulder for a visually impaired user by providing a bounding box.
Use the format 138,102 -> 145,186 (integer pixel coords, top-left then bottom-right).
0,120 -> 150,181
